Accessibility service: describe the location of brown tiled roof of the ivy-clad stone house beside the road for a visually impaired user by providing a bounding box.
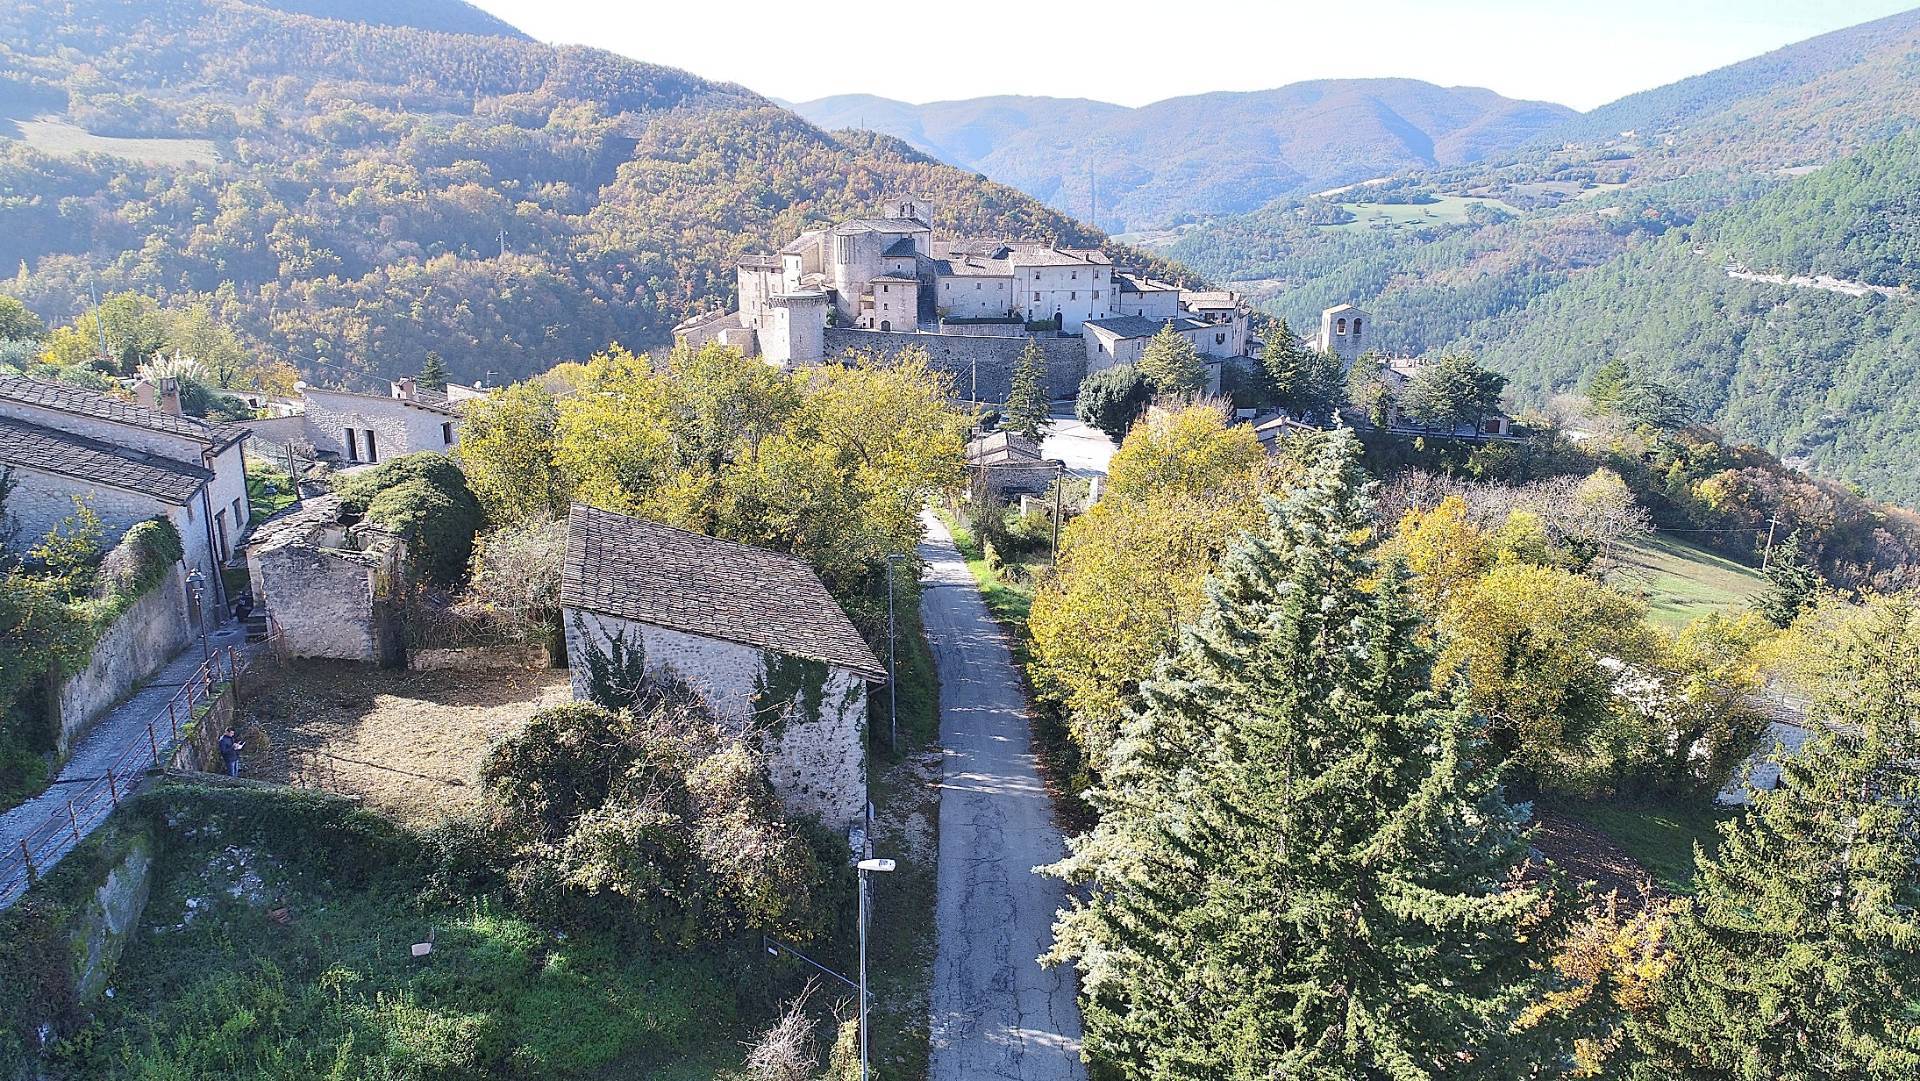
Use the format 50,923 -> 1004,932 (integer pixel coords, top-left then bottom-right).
561,503 -> 887,680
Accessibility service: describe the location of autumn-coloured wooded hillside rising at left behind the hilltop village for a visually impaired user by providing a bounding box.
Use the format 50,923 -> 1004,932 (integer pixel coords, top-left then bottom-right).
0,0 -> 1096,389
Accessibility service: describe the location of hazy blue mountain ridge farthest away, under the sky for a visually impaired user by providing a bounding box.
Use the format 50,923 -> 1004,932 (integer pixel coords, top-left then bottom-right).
793,79 -> 1578,232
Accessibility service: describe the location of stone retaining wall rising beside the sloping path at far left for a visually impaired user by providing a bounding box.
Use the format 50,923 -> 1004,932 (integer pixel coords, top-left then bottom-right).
52,565 -> 192,757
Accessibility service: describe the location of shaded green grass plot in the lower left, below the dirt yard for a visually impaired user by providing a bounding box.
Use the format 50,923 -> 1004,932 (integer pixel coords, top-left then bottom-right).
26,789 -> 768,1081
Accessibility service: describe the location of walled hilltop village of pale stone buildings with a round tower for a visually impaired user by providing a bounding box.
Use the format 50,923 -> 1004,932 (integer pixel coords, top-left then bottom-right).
674,198 -> 1250,399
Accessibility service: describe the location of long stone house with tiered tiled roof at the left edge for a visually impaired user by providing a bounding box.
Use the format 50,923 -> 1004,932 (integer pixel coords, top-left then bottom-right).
0,376 -> 252,626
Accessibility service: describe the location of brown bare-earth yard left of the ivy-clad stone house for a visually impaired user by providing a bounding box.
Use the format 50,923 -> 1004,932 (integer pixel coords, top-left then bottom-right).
240,661 -> 570,826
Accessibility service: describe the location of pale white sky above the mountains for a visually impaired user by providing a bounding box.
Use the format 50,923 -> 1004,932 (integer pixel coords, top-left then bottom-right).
476,0 -> 1914,109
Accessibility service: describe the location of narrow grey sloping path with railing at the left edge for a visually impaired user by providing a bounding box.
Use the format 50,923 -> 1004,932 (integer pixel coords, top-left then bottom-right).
0,624 -> 246,908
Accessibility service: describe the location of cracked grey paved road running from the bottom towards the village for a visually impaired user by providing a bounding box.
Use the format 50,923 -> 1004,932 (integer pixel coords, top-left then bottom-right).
920,515 -> 1087,1081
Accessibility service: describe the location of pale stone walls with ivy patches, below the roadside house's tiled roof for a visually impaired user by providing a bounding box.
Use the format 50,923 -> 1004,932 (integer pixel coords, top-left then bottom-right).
564,609 -> 866,829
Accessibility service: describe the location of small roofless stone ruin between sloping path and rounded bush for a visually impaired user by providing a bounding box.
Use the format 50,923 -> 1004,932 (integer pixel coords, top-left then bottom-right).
246,493 -> 407,664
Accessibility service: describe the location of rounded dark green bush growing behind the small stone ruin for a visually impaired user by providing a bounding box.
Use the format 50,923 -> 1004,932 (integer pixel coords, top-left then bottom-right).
336,451 -> 482,586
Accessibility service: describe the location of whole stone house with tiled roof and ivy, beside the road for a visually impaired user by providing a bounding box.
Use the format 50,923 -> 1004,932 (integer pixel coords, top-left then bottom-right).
561,503 -> 887,831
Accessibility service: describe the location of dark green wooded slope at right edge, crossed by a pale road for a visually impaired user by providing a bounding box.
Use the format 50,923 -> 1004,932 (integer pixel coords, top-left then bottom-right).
1469,134 -> 1920,505
